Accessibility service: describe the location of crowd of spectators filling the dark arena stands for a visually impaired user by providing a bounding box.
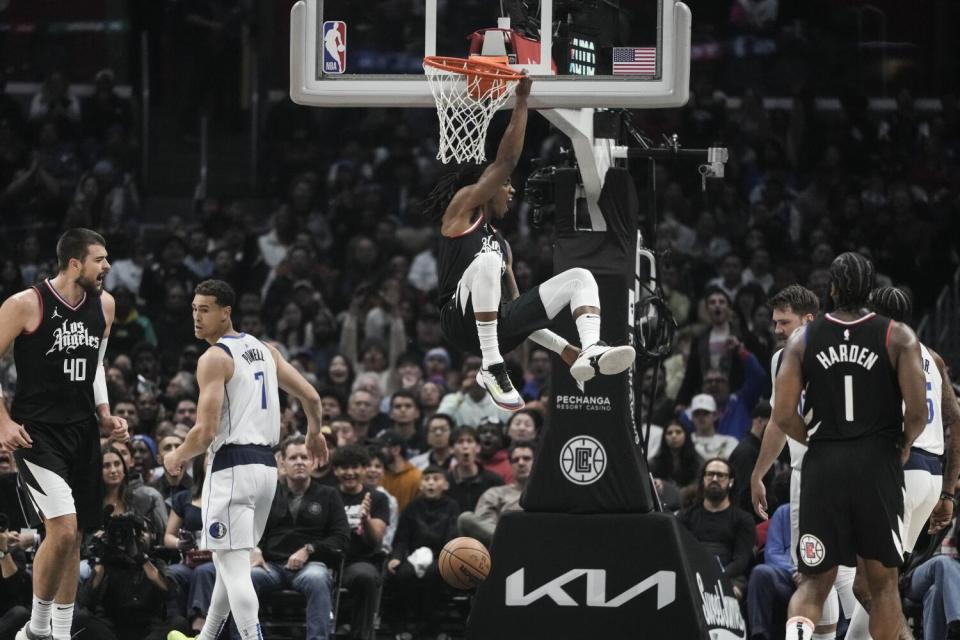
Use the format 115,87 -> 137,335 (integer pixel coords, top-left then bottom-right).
0,3 -> 960,640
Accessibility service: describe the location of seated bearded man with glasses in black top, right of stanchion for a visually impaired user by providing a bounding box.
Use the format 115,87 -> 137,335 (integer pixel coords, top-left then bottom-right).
678,458 -> 756,600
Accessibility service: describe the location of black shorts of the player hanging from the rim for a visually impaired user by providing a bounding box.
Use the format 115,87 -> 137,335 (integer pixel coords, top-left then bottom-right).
440,286 -> 550,356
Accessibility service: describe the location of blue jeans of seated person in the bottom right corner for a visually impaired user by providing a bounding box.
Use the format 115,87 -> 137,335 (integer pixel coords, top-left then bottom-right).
908,556 -> 960,640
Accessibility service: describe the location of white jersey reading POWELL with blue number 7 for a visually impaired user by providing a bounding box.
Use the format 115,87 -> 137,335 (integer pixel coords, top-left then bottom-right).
210,333 -> 280,453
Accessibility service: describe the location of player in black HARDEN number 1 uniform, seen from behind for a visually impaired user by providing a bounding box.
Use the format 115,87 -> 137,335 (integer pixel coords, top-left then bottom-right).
773,253 -> 927,640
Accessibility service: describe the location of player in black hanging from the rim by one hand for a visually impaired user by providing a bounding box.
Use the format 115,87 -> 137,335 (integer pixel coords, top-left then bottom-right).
424,71 -> 635,411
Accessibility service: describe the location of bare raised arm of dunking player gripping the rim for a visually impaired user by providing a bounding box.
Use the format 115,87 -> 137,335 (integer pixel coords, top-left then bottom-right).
443,76 -> 532,221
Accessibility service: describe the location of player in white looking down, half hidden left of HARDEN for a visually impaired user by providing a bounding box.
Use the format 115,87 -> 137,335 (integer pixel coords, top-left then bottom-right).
750,285 -> 856,640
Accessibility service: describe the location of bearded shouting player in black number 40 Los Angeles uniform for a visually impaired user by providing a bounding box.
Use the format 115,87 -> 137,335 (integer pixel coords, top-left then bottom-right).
0,229 -> 127,640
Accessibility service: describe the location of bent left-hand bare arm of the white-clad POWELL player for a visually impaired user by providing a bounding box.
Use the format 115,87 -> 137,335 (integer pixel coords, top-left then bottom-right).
163,347 -> 233,476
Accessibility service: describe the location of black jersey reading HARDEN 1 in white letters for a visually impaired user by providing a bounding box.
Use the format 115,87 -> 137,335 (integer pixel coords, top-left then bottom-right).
803,313 -> 903,442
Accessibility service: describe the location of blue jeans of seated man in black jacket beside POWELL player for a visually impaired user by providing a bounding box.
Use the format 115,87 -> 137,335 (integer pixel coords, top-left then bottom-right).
250,562 -> 333,640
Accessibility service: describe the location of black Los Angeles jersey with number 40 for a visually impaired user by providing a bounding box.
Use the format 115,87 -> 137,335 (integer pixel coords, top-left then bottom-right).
10,280 -> 107,424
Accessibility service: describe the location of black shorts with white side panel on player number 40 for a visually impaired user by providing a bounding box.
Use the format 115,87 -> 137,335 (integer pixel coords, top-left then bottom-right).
14,418 -> 103,531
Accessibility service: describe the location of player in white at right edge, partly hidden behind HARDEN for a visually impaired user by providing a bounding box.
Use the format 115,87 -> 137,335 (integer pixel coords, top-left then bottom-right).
846,287 -> 960,640
